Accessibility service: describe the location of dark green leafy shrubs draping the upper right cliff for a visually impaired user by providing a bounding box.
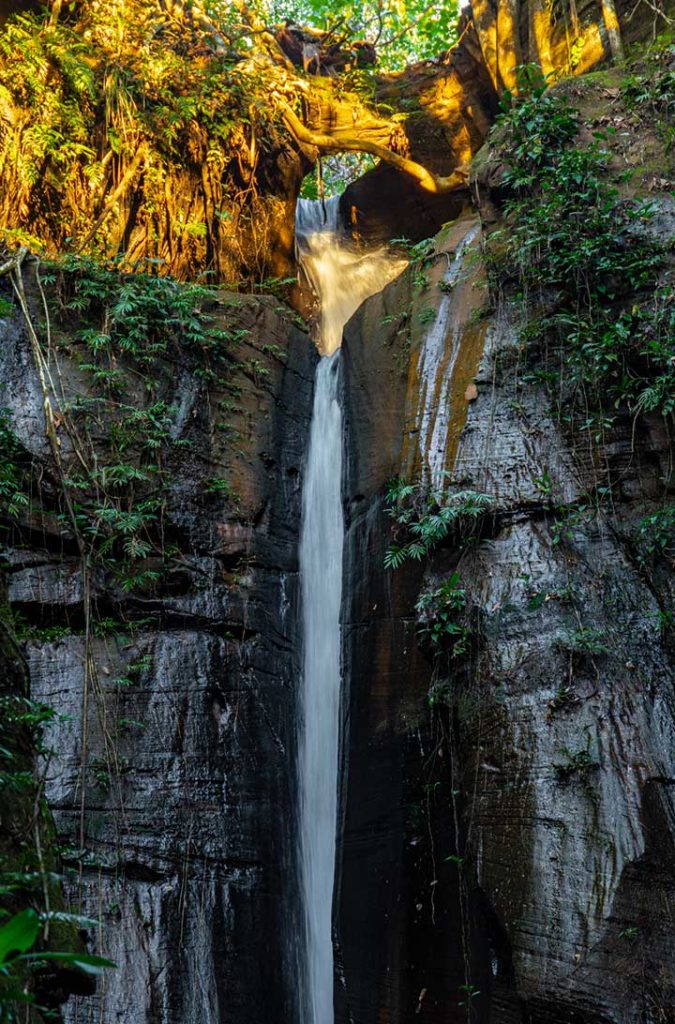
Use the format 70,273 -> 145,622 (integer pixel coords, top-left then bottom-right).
491,78 -> 675,423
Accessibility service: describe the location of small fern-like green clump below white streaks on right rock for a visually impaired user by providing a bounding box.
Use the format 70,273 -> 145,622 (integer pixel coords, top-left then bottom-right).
384,479 -> 494,569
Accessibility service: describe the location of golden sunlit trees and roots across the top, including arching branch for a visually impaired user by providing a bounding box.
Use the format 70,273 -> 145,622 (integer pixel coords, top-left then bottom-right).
0,0 -> 475,283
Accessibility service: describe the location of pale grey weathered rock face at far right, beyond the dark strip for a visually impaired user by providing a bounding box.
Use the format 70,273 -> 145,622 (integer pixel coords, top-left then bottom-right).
450,313 -> 675,1022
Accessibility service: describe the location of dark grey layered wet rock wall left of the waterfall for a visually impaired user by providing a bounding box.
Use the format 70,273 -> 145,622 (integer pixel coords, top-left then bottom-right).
0,290 -> 315,1024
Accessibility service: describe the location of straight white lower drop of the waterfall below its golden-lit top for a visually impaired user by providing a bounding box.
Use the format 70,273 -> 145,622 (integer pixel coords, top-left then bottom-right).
299,352 -> 344,1024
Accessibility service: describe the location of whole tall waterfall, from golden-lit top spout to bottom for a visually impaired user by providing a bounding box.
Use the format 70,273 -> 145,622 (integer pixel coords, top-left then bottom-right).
296,199 -> 405,1024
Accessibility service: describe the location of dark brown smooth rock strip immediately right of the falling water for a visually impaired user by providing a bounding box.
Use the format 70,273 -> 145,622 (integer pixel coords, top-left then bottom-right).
336,211 -> 481,1024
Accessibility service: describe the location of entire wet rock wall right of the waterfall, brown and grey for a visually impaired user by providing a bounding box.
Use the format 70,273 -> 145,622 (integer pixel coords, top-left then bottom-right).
338,201 -> 675,1024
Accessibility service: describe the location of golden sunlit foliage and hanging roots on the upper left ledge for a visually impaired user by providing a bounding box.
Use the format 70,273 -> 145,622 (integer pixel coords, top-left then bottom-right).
0,0 -> 303,281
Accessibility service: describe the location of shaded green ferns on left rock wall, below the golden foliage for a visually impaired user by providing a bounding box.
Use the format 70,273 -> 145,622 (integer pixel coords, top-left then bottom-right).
34,257 -> 238,592
